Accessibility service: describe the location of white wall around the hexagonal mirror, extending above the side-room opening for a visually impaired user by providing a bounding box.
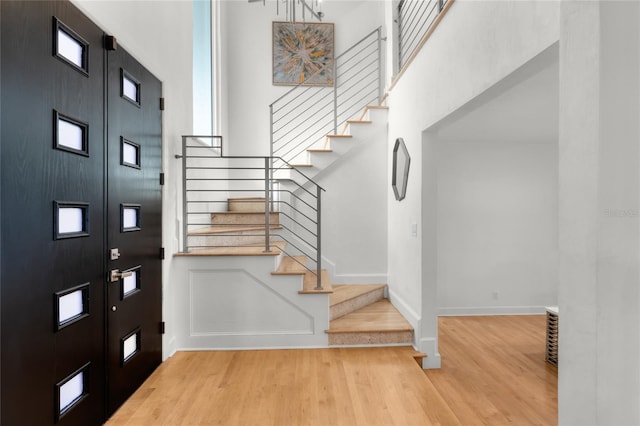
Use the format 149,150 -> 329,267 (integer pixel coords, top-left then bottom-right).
388,0 -> 559,367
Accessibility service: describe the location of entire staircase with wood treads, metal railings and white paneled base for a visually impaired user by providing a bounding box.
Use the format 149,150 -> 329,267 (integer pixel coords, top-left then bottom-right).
175,15 -> 462,352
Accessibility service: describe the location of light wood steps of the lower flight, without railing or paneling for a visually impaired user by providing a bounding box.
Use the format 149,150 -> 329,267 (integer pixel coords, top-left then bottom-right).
183,192 -> 414,346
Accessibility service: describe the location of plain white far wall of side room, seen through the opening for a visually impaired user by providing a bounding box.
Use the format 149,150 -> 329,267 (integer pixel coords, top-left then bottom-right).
436,140 -> 558,315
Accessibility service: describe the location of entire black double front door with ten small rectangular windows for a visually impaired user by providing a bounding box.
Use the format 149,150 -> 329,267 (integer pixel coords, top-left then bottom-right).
0,1 -> 161,425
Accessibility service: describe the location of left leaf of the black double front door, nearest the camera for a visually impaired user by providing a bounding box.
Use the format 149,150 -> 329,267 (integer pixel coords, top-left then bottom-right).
0,1 -> 105,425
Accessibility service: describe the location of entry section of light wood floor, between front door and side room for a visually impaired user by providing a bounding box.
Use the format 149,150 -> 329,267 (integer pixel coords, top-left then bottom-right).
107,347 -> 457,426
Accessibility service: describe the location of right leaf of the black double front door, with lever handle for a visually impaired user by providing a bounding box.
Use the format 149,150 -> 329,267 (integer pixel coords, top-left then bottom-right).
107,42 -> 162,413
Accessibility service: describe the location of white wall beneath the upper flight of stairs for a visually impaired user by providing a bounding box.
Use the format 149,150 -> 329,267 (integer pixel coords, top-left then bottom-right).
312,110 -> 388,284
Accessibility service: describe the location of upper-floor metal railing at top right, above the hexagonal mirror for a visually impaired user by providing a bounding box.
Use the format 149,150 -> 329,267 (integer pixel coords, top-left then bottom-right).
397,0 -> 447,70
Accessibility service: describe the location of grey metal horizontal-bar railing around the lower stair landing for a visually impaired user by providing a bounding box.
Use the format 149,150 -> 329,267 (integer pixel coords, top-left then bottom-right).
176,136 -> 324,290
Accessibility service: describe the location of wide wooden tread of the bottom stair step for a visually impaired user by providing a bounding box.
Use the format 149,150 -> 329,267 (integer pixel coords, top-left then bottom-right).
326,299 -> 413,334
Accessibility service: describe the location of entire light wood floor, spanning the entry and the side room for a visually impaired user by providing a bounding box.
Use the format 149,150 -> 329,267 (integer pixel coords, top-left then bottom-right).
107,316 -> 557,426
